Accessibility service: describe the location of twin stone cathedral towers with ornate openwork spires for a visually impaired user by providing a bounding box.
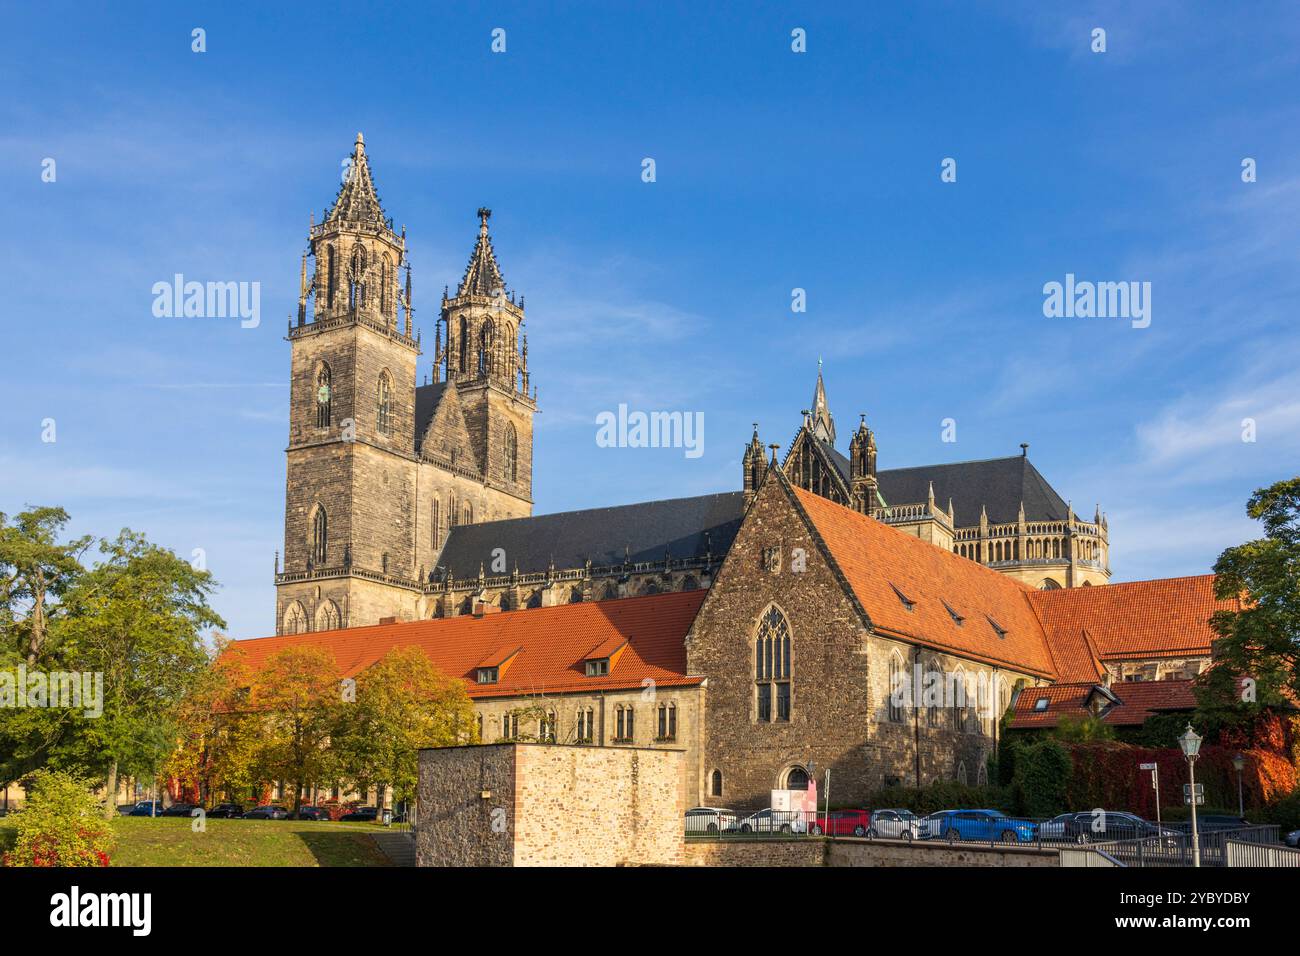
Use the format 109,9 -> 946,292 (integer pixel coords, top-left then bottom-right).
276,133 -> 537,633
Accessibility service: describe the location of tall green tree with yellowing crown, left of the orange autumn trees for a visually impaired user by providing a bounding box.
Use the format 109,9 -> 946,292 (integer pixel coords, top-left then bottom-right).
62,529 -> 225,817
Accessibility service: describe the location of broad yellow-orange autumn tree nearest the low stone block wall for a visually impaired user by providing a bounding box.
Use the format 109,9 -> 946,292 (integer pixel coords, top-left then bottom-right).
333,648 -> 475,812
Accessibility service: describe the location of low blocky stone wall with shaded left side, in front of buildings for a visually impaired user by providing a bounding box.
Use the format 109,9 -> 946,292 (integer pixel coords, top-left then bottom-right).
416,743 -> 686,866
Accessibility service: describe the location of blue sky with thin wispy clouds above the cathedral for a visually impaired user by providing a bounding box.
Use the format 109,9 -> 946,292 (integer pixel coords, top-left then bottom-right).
0,1 -> 1300,637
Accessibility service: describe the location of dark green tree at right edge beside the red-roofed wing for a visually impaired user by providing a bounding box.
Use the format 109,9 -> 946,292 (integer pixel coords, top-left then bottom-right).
1197,477 -> 1300,722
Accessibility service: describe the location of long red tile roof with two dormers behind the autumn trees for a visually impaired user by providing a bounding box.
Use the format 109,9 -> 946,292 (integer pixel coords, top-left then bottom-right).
228,591 -> 707,697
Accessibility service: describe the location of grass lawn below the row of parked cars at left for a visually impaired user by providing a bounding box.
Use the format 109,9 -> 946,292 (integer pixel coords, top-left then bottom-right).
0,817 -> 391,866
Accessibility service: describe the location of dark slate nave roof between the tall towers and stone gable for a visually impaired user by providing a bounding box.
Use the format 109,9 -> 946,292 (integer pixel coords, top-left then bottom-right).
437,492 -> 745,579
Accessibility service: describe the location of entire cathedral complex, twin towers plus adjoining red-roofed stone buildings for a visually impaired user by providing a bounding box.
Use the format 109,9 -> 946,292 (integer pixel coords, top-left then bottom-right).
244,134 -> 1238,808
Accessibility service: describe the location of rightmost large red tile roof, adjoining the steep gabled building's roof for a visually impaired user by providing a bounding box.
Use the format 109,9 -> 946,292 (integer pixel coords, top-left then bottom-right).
1030,575 -> 1240,682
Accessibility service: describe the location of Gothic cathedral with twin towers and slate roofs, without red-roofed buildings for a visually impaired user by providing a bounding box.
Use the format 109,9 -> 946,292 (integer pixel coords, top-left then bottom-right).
276,134 -> 1110,633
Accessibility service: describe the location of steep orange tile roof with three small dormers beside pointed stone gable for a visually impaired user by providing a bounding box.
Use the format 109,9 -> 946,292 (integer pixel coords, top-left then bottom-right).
792,488 -> 1056,676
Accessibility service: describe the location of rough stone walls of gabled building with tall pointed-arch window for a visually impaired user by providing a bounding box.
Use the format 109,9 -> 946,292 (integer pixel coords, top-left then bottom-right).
686,481 -> 1037,806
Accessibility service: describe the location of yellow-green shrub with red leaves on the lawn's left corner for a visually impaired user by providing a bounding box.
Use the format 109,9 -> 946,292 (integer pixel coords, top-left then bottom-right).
4,770 -> 113,866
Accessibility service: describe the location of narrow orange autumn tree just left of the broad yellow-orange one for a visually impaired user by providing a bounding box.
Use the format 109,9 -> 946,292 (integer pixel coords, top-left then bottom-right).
252,645 -> 342,814
